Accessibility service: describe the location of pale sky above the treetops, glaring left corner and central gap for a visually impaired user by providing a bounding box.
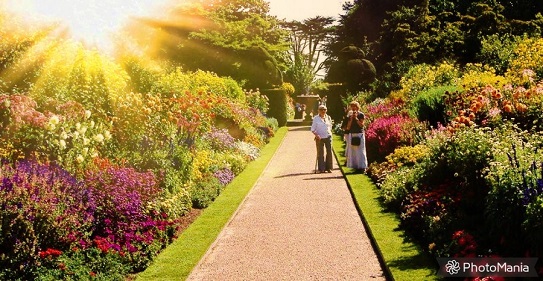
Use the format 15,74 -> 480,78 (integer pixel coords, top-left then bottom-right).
0,0 -> 347,51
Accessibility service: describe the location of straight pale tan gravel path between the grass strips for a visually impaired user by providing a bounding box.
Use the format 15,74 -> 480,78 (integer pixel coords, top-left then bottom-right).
188,127 -> 386,281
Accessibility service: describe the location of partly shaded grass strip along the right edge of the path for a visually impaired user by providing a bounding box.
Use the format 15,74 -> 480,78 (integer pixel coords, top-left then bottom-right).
332,135 -> 441,281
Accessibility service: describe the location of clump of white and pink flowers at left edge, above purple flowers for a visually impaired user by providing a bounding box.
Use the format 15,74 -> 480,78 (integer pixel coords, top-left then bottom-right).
0,95 -> 112,174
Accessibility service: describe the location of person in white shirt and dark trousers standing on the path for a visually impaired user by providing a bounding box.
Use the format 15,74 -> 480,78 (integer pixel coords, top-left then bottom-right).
311,105 -> 332,173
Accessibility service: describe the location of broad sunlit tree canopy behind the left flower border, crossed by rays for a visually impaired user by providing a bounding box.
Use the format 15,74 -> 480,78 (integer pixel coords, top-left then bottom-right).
119,0 -> 288,88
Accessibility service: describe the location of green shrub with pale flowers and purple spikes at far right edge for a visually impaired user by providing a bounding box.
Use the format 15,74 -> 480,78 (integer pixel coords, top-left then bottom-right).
485,127 -> 543,256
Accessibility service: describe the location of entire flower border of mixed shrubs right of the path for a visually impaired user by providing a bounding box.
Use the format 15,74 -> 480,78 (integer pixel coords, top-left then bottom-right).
366,36 -> 543,262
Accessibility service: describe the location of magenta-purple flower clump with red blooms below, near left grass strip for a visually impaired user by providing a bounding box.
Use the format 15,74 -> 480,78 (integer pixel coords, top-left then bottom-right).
83,164 -> 175,270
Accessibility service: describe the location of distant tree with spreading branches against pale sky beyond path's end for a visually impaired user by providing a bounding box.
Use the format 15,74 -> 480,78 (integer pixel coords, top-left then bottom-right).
283,16 -> 334,94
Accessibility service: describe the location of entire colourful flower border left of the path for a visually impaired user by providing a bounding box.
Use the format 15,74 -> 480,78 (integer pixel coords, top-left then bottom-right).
0,17 -> 278,280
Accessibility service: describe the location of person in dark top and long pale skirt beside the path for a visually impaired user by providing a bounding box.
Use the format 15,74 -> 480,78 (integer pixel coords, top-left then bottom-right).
341,101 -> 368,172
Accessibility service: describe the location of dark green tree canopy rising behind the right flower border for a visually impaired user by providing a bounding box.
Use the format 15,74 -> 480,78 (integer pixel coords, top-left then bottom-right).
326,0 -> 543,94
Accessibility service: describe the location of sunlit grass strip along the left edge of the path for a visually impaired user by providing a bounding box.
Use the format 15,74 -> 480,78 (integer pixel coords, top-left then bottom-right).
136,127 -> 288,281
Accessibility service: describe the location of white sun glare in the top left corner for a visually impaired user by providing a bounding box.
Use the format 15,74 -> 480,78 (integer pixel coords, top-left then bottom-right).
0,0 -> 168,51
